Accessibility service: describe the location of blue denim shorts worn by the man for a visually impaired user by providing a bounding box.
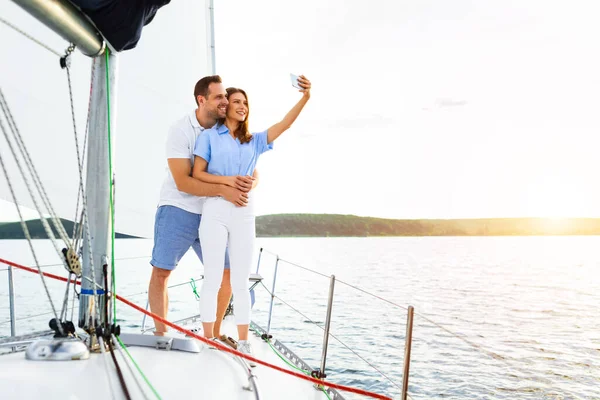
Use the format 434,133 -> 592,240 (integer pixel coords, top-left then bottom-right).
150,206 -> 229,271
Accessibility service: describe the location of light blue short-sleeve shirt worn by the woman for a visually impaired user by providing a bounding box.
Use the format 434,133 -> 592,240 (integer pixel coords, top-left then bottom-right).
194,125 -> 273,176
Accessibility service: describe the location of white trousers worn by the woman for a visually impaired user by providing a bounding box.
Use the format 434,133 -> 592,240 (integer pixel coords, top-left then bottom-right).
200,196 -> 256,325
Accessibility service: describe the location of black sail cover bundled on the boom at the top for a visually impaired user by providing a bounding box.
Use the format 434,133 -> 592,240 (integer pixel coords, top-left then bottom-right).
71,0 -> 171,51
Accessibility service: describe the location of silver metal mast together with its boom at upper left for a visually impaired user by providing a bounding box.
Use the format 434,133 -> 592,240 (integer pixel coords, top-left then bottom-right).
13,0 -> 117,333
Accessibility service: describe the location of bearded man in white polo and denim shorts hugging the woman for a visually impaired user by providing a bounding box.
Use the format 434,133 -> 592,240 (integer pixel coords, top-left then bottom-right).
148,75 -> 256,344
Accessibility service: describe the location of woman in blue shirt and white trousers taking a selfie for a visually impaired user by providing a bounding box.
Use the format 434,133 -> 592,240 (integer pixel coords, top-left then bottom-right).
193,75 -> 311,366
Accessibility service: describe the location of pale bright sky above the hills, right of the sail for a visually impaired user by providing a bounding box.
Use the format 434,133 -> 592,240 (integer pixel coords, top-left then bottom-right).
0,0 -> 600,225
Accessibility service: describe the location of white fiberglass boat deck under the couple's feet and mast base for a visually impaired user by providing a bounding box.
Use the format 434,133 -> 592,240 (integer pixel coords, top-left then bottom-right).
0,317 -> 327,400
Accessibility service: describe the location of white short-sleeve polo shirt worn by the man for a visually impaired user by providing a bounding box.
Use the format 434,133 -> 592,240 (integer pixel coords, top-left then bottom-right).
158,110 -> 205,214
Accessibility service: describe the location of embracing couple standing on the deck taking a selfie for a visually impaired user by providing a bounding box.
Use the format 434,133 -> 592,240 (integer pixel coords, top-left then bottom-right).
148,75 -> 311,366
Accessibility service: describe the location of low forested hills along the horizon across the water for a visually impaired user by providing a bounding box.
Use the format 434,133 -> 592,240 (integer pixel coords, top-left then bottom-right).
0,214 -> 600,239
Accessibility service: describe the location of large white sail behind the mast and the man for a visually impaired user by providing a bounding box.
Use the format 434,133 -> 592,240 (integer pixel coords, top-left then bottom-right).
0,0 -> 213,237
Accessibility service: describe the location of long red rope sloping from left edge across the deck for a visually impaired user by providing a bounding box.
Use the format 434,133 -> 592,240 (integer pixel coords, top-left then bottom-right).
0,258 -> 392,400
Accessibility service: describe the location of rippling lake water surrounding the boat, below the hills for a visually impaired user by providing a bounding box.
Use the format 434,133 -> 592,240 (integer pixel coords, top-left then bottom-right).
0,237 -> 600,399
